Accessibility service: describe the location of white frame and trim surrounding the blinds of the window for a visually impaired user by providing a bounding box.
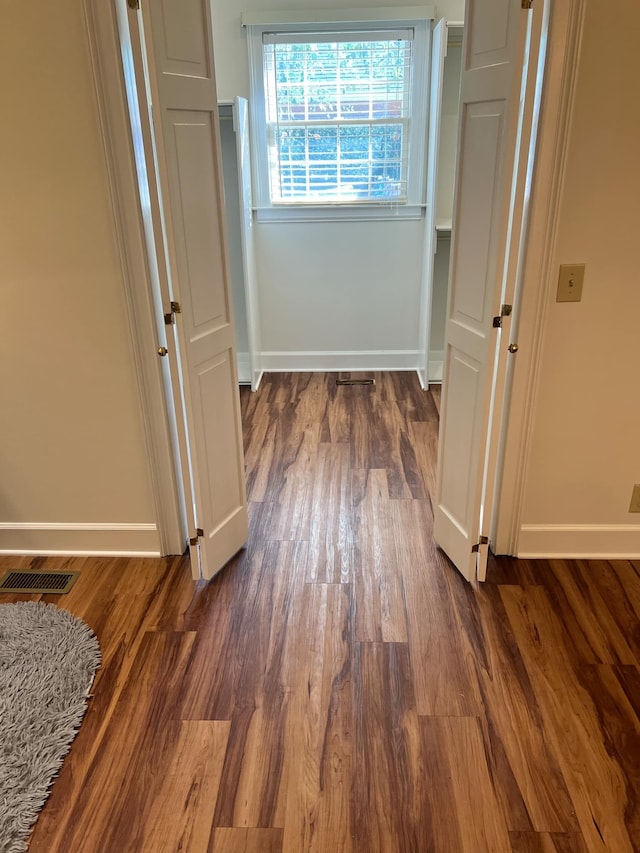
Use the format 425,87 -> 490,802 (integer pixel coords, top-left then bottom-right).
246,17 -> 432,222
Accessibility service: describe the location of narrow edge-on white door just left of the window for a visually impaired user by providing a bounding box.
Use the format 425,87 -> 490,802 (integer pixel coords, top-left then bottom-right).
233,98 -> 262,391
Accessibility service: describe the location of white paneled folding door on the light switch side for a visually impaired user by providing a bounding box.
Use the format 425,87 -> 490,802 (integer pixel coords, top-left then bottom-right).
434,0 -> 535,580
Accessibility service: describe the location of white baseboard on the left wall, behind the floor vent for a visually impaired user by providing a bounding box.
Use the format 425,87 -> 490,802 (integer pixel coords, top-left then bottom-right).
0,522 -> 161,557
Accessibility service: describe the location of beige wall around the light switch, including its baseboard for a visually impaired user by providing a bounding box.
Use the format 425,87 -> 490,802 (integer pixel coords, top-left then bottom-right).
520,0 -> 640,555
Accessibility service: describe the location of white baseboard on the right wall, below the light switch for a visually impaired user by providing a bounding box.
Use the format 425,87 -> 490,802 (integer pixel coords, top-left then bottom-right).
516,524 -> 640,560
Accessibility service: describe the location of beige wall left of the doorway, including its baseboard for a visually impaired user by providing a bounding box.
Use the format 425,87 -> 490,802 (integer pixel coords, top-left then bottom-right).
0,0 -> 157,550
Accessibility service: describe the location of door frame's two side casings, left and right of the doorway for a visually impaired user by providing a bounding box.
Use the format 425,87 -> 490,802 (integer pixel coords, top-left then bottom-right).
83,0 -> 586,554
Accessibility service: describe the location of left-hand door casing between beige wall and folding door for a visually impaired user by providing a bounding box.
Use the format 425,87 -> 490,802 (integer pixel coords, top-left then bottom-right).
83,0 -> 189,555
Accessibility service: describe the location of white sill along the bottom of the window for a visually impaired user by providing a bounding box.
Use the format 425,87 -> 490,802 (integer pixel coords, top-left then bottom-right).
254,204 -> 424,222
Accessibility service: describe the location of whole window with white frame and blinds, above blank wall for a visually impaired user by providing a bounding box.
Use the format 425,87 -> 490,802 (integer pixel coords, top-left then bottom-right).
245,14 -> 427,218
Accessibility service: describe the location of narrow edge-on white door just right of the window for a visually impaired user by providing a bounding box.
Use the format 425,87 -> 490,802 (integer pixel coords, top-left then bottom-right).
418,20 -> 447,388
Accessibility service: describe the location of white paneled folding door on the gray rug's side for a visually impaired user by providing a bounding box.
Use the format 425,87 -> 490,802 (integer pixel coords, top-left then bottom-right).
142,0 -> 248,578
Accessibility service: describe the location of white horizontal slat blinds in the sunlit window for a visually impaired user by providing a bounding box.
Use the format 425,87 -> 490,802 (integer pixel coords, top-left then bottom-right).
262,28 -> 414,204
